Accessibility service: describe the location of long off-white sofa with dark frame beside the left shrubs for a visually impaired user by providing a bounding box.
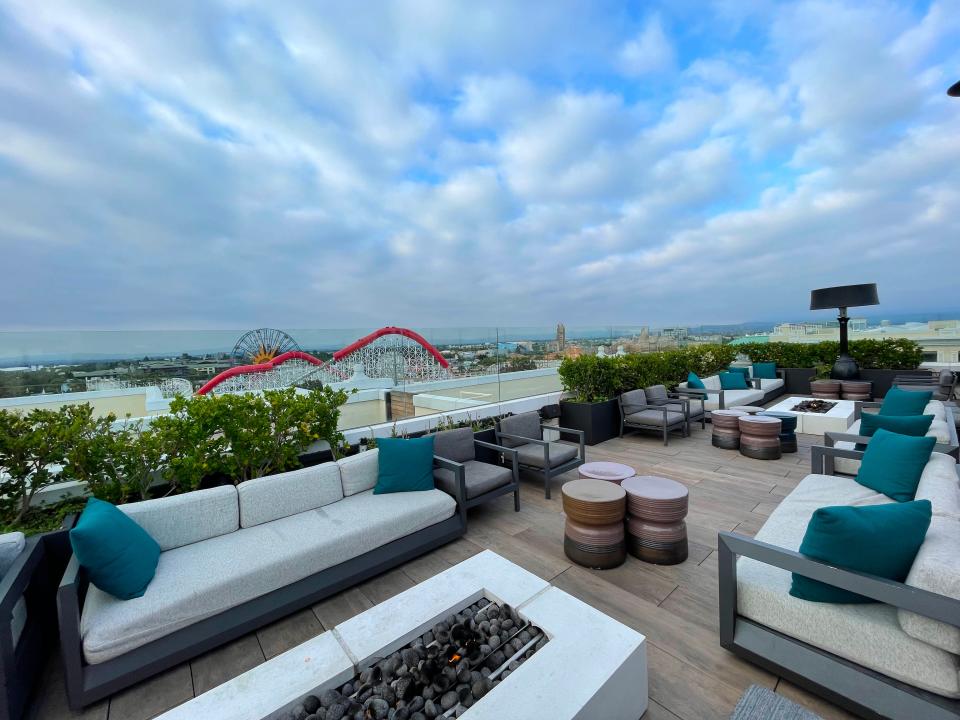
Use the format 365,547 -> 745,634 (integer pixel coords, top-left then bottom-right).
58,450 -> 466,707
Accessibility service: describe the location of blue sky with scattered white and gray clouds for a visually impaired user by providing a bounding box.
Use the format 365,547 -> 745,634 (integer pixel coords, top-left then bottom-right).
0,0 -> 960,329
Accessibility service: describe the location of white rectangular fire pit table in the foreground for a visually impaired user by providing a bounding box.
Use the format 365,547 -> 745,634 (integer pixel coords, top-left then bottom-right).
160,550 -> 647,720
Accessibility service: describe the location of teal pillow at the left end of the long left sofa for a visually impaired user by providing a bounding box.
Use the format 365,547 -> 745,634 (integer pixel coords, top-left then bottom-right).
70,498 -> 160,600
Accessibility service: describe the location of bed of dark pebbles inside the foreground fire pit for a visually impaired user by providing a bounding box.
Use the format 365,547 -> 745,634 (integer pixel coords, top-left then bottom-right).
284,598 -> 547,720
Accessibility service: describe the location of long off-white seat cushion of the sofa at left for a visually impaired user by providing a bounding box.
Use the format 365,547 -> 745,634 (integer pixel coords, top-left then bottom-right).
80,490 -> 456,664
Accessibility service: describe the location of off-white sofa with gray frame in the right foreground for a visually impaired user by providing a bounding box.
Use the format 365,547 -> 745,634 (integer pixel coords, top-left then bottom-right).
719,448 -> 960,718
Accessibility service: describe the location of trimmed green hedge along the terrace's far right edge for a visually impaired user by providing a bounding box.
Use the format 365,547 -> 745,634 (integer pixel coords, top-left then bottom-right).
560,338 -> 921,402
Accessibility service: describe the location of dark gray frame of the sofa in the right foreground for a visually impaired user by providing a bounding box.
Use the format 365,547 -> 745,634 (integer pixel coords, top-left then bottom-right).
717,447 -> 960,720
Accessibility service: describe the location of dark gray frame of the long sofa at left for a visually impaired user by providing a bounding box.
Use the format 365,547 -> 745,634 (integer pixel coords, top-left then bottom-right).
57,485 -> 467,710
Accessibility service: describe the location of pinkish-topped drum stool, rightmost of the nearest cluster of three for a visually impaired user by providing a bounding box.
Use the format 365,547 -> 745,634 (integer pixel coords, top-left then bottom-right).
621,475 -> 689,565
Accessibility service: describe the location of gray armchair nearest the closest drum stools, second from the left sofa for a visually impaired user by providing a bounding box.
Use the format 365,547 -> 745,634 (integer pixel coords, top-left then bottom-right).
497,412 -> 586,499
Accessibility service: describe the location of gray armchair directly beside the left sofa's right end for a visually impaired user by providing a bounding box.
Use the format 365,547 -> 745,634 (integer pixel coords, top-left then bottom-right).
433,427 -> 520,512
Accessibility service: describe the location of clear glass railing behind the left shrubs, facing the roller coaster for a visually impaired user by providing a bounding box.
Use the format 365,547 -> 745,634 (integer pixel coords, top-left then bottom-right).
0,325 -> 676,429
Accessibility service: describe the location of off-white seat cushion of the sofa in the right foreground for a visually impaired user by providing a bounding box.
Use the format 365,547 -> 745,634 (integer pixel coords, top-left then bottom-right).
737,492 -> 960,698
